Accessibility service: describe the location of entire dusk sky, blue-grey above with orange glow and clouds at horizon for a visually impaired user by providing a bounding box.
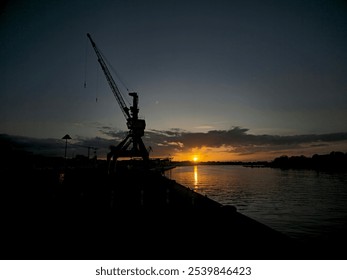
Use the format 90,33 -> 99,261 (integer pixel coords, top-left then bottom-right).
0,0 -> 347,160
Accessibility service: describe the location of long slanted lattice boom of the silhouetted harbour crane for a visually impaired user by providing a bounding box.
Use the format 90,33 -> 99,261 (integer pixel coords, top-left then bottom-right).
87,33 -> 131,120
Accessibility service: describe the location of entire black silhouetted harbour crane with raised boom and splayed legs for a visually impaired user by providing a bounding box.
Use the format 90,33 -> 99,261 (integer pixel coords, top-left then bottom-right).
87,33 -> 149,172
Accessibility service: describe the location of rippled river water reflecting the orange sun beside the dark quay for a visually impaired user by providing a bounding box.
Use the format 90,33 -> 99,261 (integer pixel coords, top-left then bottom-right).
165,165 -> 347,240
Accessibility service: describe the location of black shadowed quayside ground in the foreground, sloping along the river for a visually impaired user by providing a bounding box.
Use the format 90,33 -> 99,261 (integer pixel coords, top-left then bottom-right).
0,164 -> 347,260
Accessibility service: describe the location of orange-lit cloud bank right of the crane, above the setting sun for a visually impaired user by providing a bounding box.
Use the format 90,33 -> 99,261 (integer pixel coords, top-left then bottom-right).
141,127 -> 347,158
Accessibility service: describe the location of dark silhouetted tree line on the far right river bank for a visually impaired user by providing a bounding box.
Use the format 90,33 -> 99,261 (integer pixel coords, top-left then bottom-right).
269,152 -> 347,171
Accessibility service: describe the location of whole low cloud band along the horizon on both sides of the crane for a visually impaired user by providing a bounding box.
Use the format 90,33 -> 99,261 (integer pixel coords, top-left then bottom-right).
0,127 -> 347,158
